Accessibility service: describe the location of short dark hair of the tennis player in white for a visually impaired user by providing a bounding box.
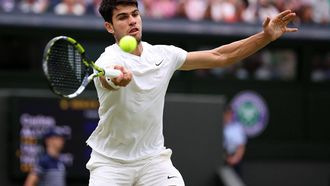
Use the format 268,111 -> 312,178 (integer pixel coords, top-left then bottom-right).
99,0 -> 138,23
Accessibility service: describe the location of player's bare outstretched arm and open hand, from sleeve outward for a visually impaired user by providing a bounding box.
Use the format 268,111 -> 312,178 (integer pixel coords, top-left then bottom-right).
180,10 -> 298,70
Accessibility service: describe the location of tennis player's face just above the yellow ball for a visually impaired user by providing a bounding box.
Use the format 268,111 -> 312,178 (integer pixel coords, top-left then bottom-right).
105,5 -> 142,43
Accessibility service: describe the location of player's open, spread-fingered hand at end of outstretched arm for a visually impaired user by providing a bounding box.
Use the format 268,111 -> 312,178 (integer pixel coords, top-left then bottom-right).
263,10 -> 298,41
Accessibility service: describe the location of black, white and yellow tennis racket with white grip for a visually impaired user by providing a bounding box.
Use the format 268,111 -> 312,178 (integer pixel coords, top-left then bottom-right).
42,36 -> 122,99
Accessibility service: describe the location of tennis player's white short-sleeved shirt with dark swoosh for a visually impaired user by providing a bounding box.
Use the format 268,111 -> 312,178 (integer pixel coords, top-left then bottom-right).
87,42 -> 187,161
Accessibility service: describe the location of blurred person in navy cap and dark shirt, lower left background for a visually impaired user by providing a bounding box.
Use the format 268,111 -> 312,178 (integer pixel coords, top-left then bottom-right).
24,128 -> 66,186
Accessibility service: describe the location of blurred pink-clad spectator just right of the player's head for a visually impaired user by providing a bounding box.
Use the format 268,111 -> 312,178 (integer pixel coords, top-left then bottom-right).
143,0 -> 178,18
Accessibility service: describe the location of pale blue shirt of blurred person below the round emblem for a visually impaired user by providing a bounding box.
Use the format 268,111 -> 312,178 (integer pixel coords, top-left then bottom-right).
224,122 -> 247,154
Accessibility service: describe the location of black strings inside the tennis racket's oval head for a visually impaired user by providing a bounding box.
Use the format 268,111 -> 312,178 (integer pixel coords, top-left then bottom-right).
47,40 -> 88,95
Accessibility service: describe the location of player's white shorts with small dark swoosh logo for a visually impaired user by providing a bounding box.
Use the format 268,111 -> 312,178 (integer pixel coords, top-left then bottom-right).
86,149 -> 184,186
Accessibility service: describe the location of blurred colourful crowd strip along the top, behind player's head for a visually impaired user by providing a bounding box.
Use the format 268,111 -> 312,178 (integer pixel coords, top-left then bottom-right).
0,0 -> 330,24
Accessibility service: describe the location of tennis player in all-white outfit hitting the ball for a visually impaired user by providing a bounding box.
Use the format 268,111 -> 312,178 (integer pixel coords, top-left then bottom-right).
86,0 -> 297,186
